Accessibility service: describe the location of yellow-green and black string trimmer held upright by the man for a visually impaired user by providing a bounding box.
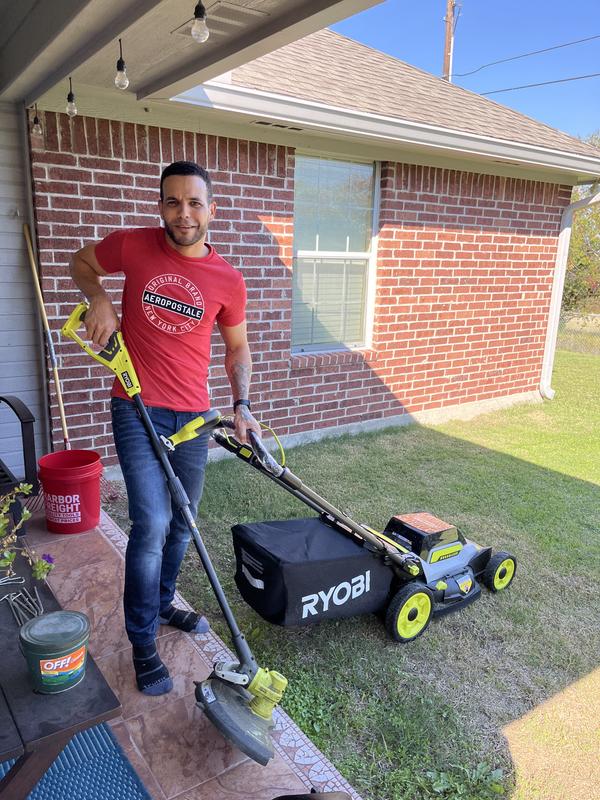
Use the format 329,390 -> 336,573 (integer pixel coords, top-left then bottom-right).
62,303 -> 287,765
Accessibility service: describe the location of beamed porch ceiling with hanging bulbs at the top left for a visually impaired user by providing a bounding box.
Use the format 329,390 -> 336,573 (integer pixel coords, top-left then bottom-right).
0,0 -> 382,105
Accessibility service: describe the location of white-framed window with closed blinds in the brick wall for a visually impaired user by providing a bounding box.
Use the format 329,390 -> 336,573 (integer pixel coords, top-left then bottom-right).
292,155 -> 374,351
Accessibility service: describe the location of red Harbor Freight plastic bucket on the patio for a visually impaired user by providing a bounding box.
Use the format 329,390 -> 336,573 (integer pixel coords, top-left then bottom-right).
38,450 -> 102,533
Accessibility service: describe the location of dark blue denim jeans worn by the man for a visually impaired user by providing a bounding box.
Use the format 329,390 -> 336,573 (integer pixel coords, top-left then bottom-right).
111,397 -> 210,645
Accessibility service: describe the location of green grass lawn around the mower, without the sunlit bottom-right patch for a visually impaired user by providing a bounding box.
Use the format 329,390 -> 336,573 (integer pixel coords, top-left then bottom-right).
159,352 -> 600,800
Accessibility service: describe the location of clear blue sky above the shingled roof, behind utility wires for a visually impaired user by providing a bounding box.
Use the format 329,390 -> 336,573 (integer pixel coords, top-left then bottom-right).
333,0 -> 600,137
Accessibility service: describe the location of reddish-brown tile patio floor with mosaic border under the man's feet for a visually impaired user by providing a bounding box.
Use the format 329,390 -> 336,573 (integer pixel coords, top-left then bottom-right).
27,513 -> 360,800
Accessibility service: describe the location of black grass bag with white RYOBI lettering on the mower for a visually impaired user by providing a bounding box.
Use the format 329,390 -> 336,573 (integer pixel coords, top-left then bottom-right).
231,517 -> 394,627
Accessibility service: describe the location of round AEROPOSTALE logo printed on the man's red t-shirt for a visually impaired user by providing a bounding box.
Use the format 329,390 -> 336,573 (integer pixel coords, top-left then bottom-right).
142,273 -> 204,335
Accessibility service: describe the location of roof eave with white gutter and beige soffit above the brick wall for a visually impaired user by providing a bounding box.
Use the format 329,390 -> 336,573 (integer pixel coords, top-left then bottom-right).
39,76 -> 600,185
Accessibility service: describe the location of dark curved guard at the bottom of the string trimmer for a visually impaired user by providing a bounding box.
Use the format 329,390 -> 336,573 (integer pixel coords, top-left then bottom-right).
196,673 -> 275,767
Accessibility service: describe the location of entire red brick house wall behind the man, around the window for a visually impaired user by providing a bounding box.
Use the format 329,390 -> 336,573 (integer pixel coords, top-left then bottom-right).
32,113 -> 570,464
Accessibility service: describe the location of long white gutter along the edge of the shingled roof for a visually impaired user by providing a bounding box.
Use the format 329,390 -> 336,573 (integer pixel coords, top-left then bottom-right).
171,80 -> 600,183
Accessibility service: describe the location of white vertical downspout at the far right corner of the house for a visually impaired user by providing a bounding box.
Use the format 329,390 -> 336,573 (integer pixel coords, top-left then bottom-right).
540,192 -> 600,400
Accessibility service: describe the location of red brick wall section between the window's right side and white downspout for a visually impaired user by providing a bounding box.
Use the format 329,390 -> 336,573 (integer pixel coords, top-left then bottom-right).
373,164 -> 571,412
